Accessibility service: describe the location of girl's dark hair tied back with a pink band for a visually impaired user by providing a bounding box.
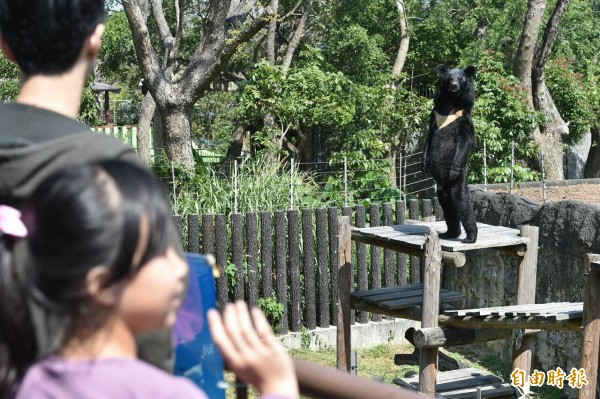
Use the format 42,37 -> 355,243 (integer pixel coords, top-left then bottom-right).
0,161 -> 171,397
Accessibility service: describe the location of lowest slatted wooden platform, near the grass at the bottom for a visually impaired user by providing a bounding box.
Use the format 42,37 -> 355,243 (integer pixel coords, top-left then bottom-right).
394,368 -> 516,399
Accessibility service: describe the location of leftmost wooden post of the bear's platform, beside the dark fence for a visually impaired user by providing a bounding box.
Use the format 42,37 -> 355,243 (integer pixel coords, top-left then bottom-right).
337,216 -> 352,372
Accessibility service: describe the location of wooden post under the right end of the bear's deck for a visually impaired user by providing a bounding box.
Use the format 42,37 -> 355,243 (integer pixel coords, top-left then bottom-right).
512,226 -> 539,376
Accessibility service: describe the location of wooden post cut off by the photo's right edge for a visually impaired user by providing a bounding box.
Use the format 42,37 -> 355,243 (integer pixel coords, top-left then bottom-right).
579,254 -> 600,399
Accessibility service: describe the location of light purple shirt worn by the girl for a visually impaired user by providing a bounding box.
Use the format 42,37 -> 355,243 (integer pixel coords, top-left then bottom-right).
15,357 -> 298,399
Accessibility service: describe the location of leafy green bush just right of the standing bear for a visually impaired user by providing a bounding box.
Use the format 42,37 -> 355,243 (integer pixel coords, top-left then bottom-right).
469,53 -> 541,182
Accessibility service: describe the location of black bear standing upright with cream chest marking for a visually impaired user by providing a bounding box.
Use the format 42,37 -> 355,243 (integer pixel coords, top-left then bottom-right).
423,65 -> 477,243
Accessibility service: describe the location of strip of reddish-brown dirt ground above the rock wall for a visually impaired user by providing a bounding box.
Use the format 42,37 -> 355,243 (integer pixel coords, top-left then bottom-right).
493,184 -> 600,206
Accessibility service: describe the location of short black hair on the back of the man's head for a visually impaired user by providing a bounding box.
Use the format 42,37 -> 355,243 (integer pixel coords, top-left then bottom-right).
0,0 -> 105,76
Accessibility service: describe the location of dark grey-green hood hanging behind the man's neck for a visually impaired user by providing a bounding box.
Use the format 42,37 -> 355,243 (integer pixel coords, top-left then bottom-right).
0,104 -> 141,207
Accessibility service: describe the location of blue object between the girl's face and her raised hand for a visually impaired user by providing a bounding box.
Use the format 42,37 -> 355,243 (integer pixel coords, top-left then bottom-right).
173,254 -> 226,399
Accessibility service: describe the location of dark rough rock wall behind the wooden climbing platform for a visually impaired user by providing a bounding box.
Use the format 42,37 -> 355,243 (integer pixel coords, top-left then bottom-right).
442,188 -> 600,394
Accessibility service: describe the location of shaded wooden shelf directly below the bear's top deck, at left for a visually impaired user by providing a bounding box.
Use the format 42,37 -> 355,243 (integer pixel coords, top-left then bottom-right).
351,284 -> 465,314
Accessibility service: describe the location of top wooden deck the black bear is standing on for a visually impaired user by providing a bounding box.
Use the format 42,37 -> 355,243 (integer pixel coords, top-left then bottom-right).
352,222 -> 529,254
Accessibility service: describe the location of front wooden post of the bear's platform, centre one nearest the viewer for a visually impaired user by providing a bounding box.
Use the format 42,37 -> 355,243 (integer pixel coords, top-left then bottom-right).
419,228 -> 442,397
